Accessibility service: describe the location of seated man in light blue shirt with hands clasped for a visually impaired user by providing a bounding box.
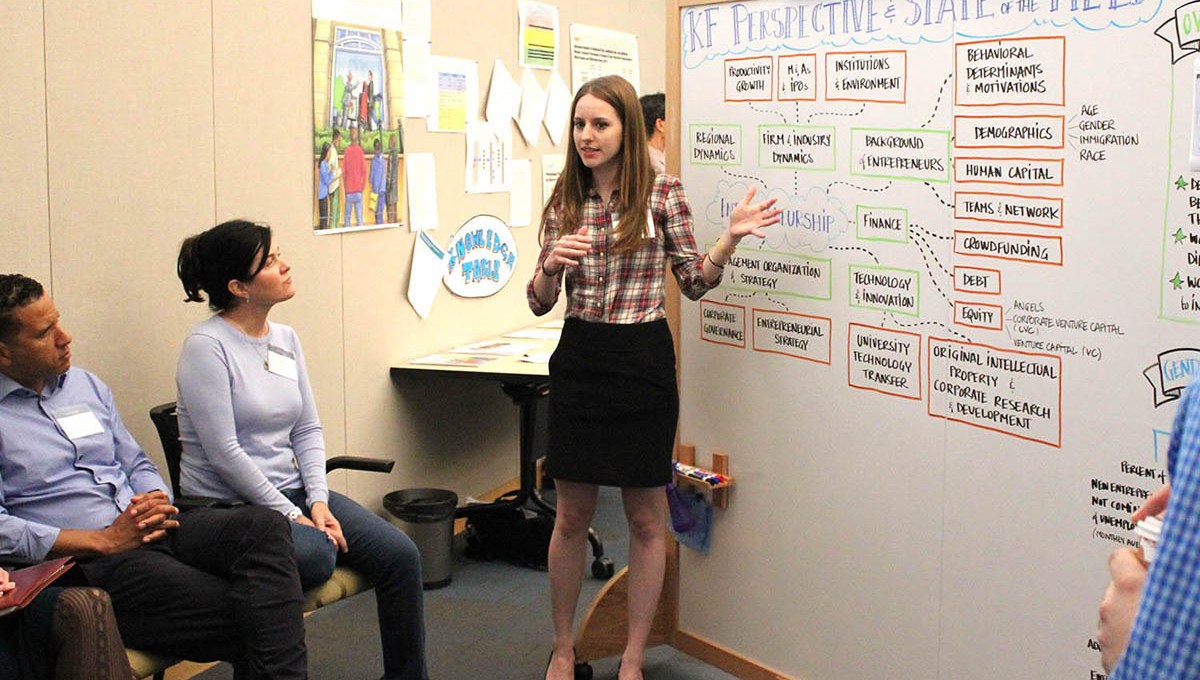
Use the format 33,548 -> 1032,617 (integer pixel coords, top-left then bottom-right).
0,275 -> 306,680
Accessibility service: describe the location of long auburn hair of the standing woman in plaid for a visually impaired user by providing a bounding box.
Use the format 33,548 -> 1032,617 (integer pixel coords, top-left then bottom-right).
538,76 -> 655,252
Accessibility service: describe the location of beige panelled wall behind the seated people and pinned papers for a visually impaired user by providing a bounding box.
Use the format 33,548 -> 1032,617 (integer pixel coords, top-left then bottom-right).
0,0 -> 665,506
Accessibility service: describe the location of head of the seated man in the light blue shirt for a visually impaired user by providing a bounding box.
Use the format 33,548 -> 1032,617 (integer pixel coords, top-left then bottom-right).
0,273 -> 72,392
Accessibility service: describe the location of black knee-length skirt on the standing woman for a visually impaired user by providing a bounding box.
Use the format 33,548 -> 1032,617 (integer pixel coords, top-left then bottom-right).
546,319 -> 679,487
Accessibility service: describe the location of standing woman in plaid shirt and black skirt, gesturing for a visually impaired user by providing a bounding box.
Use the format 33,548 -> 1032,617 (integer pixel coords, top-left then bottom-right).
527,76 -> 779,680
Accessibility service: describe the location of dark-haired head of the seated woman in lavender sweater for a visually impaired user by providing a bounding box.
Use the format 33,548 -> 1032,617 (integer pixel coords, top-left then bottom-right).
176,219 -> 295,312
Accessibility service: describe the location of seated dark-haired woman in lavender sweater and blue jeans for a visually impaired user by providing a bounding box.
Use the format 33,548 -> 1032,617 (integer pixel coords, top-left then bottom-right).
175,219 -> 428,680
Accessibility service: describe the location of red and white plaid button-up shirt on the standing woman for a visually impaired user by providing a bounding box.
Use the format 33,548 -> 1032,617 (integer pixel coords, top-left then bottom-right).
526,175 -> 721,324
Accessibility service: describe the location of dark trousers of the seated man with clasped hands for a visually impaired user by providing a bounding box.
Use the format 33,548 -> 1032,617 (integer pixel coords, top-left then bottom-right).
79,506 -> 307,680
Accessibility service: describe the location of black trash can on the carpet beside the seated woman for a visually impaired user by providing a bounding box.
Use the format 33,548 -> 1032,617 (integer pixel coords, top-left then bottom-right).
383,489 -> 458,590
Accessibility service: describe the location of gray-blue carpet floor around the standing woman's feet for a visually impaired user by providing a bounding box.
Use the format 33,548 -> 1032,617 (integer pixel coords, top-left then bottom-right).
197,489 -> 733,680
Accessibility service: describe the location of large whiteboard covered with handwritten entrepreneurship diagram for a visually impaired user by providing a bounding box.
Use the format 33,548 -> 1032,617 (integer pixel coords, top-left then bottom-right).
672,0 -> 1200,680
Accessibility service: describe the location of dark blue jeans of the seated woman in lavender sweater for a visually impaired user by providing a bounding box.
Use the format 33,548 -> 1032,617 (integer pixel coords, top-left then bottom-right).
283,489 -> 428,680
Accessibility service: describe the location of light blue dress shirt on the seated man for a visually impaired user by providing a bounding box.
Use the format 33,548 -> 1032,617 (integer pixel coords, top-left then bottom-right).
0,368 -> 170,562
